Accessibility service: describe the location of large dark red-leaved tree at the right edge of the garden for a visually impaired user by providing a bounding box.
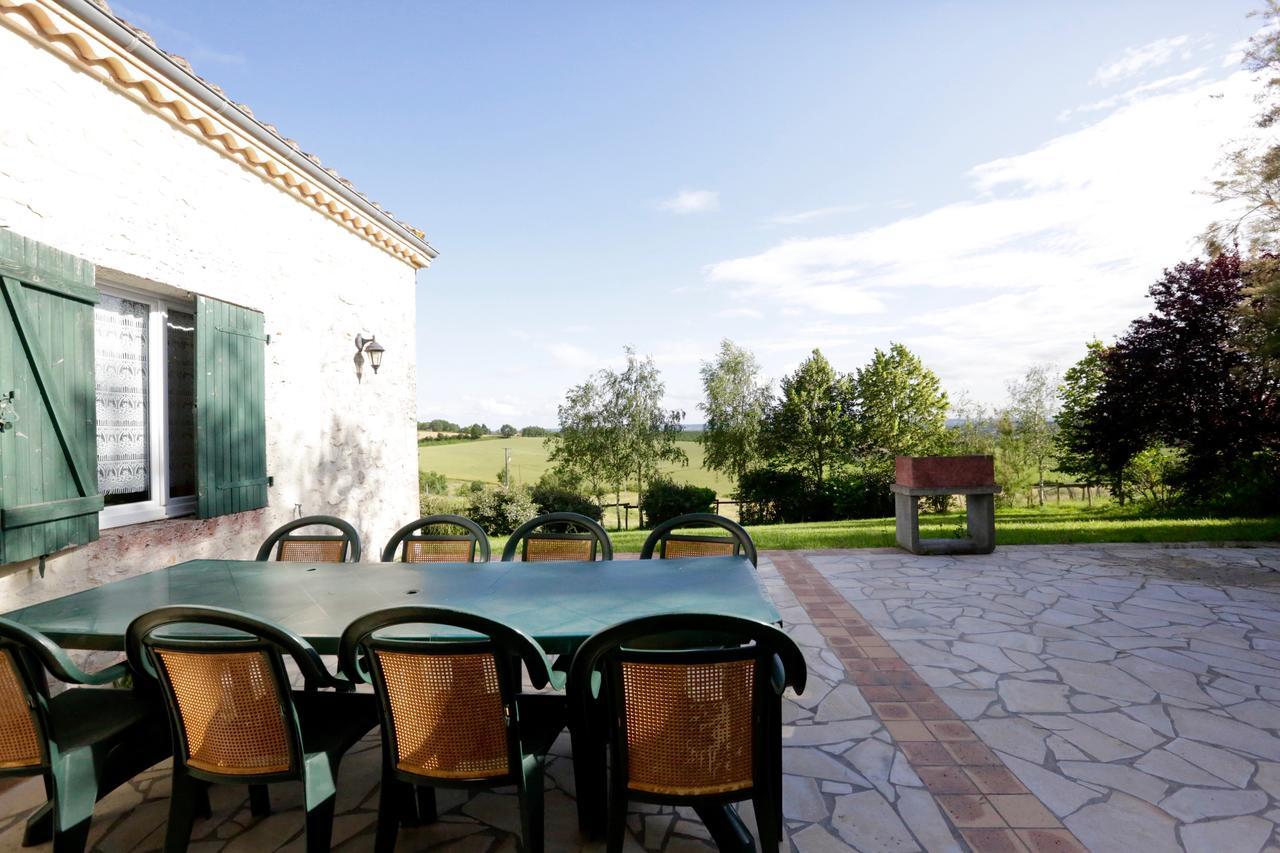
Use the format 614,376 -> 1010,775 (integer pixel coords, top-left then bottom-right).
1088,254 -> 1280,497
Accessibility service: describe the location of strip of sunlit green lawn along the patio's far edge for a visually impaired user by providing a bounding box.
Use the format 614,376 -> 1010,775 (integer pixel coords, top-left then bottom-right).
471,506 -> 1280,552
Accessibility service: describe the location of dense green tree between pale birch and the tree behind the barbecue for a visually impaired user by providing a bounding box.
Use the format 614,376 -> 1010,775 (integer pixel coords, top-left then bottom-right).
762,350 -> 854,485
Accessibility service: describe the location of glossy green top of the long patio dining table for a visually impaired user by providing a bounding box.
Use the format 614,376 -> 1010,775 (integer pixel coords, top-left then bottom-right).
5,557 -> 778,654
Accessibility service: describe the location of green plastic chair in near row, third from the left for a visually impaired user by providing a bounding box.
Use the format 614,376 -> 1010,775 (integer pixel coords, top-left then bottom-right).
339,607 -> 566,853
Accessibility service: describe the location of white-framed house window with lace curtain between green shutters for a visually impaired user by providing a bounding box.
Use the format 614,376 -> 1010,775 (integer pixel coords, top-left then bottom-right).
93,278 -> 196,528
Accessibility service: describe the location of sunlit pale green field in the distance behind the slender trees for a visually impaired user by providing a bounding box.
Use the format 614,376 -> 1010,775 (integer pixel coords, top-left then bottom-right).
417,437 -> 733,501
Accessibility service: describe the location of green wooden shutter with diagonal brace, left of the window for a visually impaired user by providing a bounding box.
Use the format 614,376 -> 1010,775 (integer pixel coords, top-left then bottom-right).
0,229 -> 102,564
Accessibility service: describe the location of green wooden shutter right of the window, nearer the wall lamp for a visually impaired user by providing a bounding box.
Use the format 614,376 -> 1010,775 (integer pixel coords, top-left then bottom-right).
196,296 -> 268,519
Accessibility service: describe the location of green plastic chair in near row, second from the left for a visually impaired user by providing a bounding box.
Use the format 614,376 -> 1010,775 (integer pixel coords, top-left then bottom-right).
125,606 -> 378,853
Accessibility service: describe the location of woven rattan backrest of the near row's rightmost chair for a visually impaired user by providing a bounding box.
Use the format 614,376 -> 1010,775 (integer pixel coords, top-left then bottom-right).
620,658 -> 755,797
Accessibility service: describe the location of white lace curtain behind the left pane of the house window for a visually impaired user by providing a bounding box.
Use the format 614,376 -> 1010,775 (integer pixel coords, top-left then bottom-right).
93,293 -> 151,502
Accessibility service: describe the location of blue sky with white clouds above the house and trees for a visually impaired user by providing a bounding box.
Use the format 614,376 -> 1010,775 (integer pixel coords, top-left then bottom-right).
113,0 -> 1260,428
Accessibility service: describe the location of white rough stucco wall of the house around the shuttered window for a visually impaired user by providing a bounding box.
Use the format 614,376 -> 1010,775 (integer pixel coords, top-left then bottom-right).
0,27 -> 417,604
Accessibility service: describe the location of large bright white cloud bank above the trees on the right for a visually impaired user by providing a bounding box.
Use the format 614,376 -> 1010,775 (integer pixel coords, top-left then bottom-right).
707,64 -> 1257,403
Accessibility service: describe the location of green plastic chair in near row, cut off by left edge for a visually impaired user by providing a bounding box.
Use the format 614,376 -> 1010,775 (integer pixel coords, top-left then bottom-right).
0,619 -> 169,853
